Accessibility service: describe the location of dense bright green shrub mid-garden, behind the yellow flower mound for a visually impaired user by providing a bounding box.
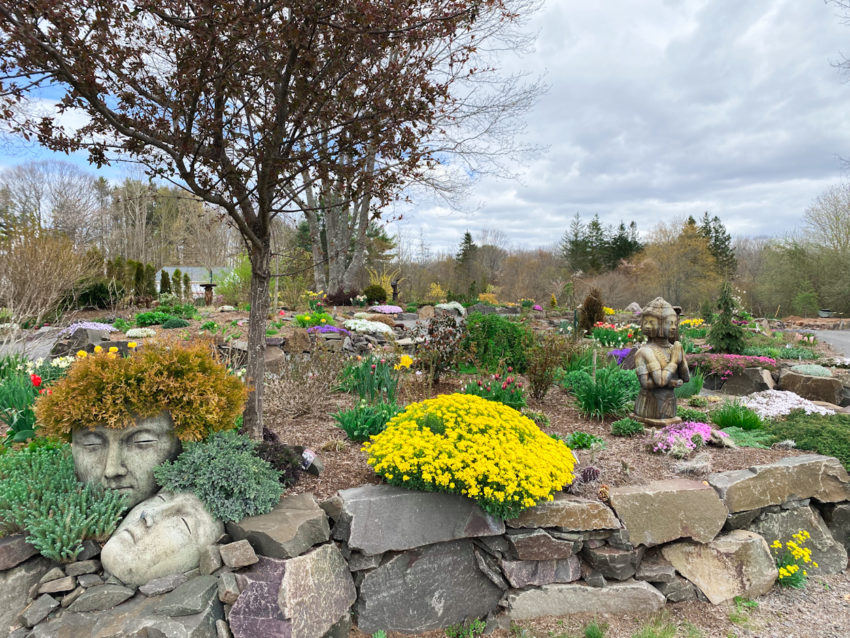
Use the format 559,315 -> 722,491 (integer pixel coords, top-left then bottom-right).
461,312 -> 533,373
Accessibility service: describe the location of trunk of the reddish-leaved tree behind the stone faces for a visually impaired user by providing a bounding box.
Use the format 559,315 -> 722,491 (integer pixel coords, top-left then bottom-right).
242,235 -> 271,441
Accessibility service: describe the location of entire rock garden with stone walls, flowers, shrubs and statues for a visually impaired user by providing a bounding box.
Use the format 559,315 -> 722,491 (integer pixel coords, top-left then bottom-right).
0,293 -> 850,638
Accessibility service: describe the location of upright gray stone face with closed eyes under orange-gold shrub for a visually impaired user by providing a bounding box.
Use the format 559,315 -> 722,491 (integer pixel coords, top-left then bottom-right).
71,413 -> 180,507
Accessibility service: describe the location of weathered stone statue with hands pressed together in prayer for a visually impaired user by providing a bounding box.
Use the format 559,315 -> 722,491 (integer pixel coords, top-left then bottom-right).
635,297 -> 690,427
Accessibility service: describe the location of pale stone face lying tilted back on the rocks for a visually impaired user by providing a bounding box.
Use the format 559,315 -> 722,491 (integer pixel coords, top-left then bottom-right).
100,492 -> 224,586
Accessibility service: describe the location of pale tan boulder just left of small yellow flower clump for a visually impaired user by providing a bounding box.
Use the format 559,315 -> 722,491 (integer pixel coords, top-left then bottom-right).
661,530 -> 777,605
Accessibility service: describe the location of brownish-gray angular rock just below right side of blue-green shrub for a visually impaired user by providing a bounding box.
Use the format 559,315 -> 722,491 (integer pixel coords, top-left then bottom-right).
227,494 -> 330,558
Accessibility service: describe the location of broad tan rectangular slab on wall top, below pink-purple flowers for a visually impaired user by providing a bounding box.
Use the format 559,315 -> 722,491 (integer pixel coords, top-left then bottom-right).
610,479 -> 727,547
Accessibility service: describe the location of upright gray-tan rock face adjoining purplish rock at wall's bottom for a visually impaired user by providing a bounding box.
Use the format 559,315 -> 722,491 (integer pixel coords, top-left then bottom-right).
277,543 -> 357,638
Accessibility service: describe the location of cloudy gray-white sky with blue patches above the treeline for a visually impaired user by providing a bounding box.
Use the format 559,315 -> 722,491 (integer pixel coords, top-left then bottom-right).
0,0 -> 850,252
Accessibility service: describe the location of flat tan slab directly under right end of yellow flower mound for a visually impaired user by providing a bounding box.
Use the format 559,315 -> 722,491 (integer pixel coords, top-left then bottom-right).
505,494 -> 622,532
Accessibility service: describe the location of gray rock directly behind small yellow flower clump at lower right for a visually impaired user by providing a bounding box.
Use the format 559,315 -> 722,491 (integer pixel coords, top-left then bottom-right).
750,507 -> 847,574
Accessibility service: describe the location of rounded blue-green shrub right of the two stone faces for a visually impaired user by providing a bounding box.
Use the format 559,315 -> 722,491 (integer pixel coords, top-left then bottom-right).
154,430 -> 283,522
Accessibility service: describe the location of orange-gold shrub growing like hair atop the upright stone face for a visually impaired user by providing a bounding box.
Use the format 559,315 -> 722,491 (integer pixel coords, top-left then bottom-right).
35,342 -> 247,441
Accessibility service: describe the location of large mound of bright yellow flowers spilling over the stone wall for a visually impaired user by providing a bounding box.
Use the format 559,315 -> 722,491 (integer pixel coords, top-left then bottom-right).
363,394 -> 575,518
